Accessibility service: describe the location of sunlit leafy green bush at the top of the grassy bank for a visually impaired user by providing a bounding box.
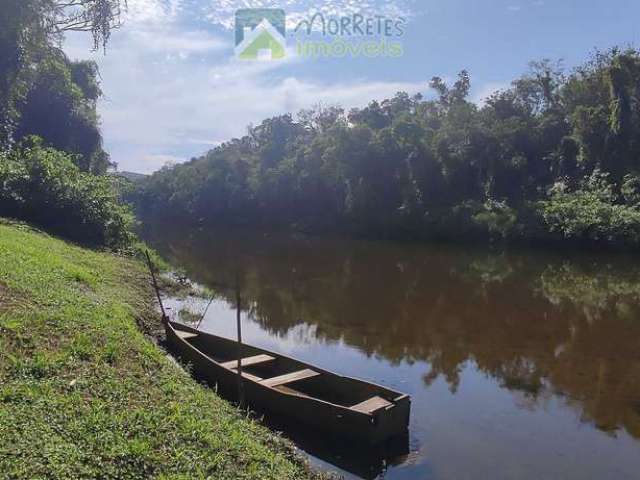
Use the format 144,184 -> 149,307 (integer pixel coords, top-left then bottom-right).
0,140 -> 135,249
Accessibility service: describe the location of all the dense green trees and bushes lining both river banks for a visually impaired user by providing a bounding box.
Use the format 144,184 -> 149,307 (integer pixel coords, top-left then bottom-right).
5,0 -> 640,248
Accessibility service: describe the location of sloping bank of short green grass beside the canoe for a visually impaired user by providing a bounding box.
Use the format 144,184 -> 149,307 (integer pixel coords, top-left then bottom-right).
0,224 -> 320,480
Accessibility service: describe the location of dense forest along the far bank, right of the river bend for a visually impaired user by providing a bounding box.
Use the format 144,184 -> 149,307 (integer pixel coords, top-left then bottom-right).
135,49 -> 640,247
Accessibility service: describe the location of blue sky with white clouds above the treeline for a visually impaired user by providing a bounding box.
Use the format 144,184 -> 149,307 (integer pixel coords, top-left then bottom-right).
64,0 -> 640,173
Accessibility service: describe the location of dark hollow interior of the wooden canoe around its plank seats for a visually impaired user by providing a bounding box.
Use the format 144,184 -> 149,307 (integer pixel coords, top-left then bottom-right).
172,323 -> 406,413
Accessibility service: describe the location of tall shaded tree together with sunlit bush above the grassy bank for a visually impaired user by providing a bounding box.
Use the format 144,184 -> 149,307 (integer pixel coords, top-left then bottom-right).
0,0 -> 135,248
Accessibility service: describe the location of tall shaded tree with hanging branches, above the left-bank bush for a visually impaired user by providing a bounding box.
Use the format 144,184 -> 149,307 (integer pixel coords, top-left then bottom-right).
0,0 -> 121,169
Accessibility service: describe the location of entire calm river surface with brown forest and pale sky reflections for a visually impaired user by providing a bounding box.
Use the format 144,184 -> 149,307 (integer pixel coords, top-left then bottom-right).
146,227 -> 640,480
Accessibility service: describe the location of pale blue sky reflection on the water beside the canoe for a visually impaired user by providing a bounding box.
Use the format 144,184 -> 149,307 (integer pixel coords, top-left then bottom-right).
162,292 -> 640,480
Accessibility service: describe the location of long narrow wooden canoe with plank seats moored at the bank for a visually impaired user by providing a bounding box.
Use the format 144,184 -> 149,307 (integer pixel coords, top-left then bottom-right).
165,321 -> 411,445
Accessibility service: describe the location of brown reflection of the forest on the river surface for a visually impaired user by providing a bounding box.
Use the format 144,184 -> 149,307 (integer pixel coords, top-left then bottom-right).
148,224 -> 640,438
